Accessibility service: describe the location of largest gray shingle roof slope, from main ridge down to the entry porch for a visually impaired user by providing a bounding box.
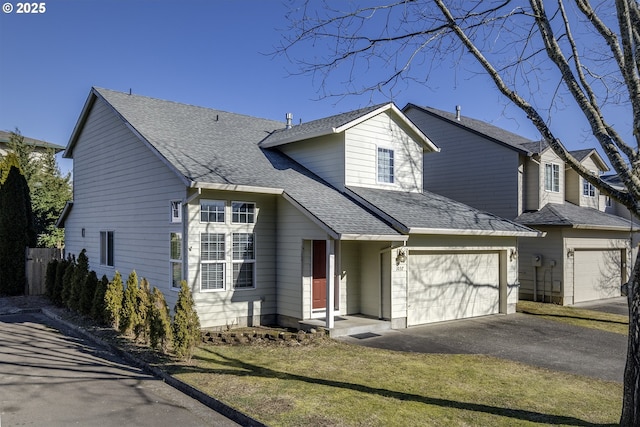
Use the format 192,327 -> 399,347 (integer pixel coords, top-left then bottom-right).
91,89 -> 399,238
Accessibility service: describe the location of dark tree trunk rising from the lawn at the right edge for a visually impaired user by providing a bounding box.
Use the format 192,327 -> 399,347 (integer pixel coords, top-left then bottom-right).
620,254 -> 640,427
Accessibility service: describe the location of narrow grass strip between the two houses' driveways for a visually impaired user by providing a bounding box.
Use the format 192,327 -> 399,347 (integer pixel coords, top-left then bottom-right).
517,301 -> 629,335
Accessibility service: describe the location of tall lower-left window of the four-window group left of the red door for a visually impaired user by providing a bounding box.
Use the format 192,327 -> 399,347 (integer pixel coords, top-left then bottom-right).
200,233 -> 226,291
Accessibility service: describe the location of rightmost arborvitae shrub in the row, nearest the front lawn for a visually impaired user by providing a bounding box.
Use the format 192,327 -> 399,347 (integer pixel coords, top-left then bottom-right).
173,280 -> 200,360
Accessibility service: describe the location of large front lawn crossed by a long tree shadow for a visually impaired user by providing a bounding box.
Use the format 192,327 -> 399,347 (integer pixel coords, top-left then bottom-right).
165,339 -> 622,426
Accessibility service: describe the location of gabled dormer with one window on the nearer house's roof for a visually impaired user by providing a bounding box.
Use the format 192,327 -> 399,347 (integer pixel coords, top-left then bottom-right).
261,103 -> 439,192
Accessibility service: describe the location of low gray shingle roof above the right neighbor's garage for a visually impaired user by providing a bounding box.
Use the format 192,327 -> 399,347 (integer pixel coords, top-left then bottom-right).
515,202 -> 637,230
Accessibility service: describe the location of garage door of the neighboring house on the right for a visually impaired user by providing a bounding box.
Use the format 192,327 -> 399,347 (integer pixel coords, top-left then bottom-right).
573,249 -> 622,303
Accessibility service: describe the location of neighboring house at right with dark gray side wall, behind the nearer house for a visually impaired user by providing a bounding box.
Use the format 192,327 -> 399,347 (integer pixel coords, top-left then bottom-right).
403,104 -> 637,304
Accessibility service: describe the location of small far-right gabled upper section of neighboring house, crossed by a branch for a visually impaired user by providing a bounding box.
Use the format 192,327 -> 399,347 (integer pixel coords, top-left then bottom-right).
565,148 -> 609,209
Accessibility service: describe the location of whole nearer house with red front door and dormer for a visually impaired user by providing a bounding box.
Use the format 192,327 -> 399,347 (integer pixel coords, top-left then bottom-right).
59,88 -> 539,334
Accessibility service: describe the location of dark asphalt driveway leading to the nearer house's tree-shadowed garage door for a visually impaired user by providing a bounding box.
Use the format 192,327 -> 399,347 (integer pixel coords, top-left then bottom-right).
341,299 -> 627,382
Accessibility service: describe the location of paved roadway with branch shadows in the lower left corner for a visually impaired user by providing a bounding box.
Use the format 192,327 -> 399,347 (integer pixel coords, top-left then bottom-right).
0,314 -> 237,427
